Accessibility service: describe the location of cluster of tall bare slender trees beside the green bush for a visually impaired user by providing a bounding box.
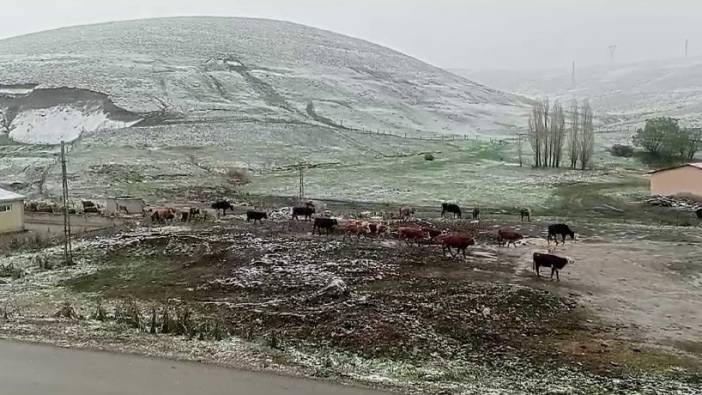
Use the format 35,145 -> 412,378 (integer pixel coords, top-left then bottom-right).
519,99 -> 595,170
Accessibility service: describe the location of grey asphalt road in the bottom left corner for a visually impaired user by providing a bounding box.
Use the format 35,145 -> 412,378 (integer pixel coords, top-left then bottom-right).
0,341 -> 382,395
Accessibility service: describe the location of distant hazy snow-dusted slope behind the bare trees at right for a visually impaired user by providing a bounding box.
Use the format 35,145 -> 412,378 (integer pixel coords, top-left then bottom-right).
454,58 -> 702,126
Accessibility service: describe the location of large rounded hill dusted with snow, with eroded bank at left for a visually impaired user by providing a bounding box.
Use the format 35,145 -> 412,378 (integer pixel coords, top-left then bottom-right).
0,17 -> 527,145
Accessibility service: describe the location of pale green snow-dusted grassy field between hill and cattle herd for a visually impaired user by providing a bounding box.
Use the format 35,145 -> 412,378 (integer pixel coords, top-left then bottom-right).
0,122 -> 676,227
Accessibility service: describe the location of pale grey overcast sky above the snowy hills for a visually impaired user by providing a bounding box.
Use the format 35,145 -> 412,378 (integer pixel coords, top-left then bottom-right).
0,0 -> 702,69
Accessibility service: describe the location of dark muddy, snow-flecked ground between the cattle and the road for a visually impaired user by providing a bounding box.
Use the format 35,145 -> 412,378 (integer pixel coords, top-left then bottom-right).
0,207 -> 702,393
